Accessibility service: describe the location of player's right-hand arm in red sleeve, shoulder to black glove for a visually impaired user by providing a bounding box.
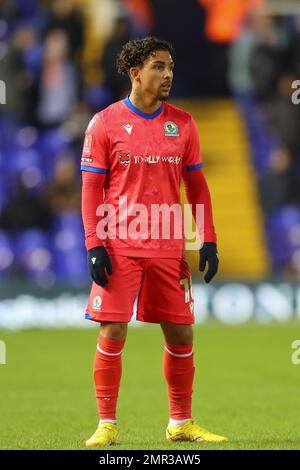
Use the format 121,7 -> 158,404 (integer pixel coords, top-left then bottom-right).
182,118 -> 219,282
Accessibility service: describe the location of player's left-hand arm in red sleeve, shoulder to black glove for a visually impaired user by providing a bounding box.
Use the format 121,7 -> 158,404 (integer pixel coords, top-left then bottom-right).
81,115 -> 112,287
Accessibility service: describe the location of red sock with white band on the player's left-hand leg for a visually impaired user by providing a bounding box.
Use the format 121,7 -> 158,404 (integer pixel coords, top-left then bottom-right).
94,334 -> 125,420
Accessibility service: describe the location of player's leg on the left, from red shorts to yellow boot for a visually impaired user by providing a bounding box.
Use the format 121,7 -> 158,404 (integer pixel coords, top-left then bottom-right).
86,256 -> 142,447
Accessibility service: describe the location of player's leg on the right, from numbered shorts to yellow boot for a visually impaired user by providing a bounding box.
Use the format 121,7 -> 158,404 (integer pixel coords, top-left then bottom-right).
137,258 -> 226,442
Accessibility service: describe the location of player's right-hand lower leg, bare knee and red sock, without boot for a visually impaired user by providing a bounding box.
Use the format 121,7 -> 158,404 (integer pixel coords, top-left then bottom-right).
160,321 -> 195,425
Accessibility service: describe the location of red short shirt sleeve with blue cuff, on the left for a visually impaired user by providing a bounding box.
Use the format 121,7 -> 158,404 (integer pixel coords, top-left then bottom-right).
81,113 -> 109,174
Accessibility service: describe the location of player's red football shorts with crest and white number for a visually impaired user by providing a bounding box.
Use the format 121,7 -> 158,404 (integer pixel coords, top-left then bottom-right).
85,255 -> 195,325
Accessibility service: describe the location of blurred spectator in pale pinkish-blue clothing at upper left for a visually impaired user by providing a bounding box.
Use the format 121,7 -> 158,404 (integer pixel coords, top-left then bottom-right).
37,30 -> 77,127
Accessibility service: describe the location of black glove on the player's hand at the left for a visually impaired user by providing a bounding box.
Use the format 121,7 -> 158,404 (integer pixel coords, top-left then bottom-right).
88,246 -> 112,287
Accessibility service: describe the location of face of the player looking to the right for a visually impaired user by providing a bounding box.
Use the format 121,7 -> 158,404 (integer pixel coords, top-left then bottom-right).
131,51 -> 174,101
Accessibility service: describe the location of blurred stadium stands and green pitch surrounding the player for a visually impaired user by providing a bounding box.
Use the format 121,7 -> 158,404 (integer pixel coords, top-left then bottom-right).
0,0 -> 300,448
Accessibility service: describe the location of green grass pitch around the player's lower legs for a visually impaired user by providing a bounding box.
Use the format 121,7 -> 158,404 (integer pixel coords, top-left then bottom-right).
0,323 -> 300,450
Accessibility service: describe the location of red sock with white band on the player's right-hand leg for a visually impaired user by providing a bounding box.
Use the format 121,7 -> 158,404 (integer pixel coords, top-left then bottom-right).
163,342 -> 195,420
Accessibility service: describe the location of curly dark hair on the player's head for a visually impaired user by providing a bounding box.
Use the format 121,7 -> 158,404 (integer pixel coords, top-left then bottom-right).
117,36 -> 175,75
